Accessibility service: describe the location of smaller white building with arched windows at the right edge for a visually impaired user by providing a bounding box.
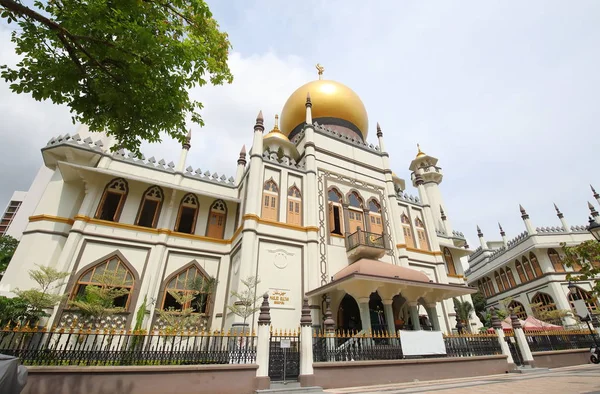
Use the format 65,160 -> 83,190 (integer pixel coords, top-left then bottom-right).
466,199 -> 600,326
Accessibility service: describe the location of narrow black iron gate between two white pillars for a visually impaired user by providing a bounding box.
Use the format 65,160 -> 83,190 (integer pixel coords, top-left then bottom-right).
269,330 -> 300,382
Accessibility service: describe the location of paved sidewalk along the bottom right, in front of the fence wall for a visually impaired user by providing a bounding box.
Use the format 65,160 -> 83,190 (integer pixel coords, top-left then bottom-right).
325,365 -> 600,394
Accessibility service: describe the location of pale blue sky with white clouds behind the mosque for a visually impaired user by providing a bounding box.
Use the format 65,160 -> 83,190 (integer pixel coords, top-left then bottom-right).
0,0 -> 600,248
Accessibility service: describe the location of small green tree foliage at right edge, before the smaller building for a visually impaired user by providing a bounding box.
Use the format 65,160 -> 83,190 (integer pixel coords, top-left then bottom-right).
561,240 -> 600,298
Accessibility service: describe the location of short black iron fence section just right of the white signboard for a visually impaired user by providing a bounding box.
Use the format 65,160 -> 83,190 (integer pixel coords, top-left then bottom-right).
444,334 -> 502,357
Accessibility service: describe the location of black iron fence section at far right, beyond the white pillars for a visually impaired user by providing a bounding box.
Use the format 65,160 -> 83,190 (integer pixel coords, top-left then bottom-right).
525,330 -> 600,352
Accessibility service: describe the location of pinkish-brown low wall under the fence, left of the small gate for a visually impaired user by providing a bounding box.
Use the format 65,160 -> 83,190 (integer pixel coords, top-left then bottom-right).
21,364 -> 258,394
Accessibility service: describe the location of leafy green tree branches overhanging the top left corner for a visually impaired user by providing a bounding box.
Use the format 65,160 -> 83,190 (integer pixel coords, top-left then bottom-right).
0,0 -> 233,153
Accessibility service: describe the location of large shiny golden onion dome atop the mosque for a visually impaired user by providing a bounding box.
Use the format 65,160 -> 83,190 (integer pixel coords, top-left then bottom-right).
281,79 -> 369,141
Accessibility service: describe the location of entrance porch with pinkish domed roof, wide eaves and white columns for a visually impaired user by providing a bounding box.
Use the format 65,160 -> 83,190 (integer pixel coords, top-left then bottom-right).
307,258 -> 477,332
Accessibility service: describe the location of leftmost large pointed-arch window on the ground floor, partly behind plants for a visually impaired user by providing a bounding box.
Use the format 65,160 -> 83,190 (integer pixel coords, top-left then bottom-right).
71,256 -> 135,309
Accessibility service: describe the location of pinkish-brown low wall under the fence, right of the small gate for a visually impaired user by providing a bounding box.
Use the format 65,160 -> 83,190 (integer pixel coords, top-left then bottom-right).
310,355 -> 509,389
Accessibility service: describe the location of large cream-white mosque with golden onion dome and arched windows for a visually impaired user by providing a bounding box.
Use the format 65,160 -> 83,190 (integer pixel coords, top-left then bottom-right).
0,66 -> 480,332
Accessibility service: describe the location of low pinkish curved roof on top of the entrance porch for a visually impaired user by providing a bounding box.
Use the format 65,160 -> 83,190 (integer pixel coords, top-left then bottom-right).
333,259 -> 429,282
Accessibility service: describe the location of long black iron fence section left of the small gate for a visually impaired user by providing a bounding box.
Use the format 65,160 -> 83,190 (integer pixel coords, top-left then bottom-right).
0,328 -> 256,365
